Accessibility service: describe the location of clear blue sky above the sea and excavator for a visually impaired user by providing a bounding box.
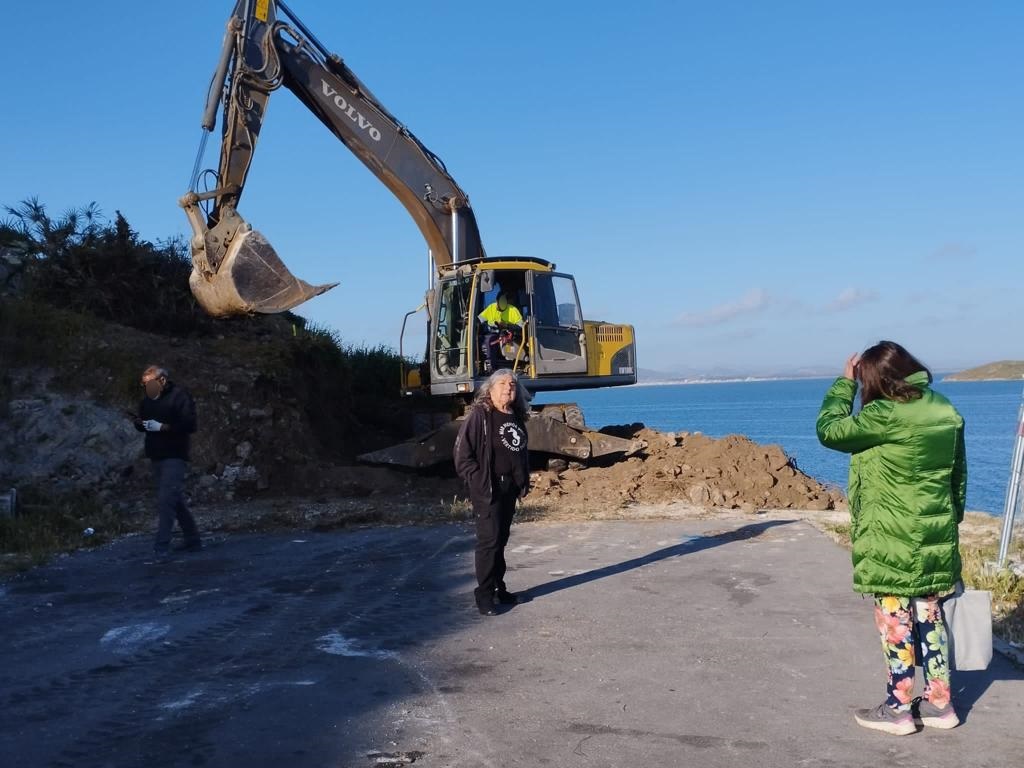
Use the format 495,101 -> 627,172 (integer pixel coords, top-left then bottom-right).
0,0 -> 1024,373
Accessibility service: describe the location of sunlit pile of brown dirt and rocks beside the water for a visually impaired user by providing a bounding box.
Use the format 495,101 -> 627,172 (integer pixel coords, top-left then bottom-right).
529,424 -> 845,512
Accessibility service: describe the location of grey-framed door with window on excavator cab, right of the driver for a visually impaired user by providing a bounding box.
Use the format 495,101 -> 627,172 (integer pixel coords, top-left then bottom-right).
529,272 -> 587,376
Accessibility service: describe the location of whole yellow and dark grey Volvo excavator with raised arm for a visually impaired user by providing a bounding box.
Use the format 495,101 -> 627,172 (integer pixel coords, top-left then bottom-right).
179,0 -> 645,468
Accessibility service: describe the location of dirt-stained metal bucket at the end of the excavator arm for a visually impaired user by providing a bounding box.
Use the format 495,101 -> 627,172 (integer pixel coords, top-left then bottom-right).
188,229 -> 338,317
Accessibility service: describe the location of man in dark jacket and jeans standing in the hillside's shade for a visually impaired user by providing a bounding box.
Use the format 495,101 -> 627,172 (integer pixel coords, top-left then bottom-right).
135,366 -> 203,555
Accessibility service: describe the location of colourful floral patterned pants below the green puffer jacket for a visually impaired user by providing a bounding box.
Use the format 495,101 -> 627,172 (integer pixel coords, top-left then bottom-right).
874,595 -> 949,712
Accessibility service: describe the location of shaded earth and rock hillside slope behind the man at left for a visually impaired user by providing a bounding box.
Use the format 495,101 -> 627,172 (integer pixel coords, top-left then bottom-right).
0,298 -> 440,505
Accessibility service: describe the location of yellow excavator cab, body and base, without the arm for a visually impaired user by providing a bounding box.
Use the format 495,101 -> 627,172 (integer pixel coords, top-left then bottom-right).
372,257 -> 646,468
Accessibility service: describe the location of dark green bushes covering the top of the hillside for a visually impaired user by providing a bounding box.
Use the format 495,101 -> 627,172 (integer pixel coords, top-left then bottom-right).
0,199 -> 409,455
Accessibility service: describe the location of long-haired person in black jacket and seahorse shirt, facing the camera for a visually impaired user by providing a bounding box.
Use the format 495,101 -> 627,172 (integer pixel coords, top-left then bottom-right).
455,369 -> 529,616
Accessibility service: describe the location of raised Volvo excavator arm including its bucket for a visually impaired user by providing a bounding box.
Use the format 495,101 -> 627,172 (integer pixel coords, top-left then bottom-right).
180,0 -> 485,316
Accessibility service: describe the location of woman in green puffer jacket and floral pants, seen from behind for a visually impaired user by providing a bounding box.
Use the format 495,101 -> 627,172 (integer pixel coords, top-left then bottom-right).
817,341 -> 967,735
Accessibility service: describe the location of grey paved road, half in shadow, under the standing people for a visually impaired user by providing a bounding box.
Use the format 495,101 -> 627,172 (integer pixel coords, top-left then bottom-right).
0,518 -> 1024,768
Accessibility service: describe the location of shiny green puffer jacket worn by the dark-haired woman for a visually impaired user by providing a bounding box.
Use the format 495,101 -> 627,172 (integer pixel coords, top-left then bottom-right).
817,371 -> 967,597
